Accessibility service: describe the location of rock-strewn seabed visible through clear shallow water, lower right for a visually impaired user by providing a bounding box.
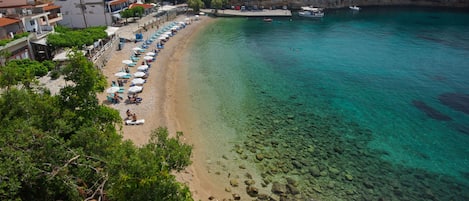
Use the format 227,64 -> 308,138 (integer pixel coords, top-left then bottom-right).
210,85 -> 469,201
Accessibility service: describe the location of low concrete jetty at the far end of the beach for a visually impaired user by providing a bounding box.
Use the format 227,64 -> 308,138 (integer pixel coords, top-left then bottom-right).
201,9 -> 292,17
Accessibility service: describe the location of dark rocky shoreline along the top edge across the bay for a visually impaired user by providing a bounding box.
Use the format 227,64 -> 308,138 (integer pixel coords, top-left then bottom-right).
230,0 -> 469,10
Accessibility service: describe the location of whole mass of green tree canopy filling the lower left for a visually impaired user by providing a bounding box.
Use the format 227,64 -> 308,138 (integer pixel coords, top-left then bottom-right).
0,51 -> 192,201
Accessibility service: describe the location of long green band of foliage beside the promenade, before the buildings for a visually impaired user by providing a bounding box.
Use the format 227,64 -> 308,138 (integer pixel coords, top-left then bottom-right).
47,26 -> 107,48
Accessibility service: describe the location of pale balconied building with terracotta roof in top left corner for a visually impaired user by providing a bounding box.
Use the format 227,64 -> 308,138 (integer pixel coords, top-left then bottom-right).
0,0 -> 62,60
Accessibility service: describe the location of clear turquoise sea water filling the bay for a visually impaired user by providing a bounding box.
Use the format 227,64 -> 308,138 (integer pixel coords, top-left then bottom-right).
185,7 -> 469,200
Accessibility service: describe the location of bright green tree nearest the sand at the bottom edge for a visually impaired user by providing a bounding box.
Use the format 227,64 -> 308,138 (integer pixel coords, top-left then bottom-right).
109,128 -> 192,201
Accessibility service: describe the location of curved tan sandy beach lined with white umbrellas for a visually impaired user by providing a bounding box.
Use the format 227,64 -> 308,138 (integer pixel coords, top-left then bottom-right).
98,15 -> 230,200
